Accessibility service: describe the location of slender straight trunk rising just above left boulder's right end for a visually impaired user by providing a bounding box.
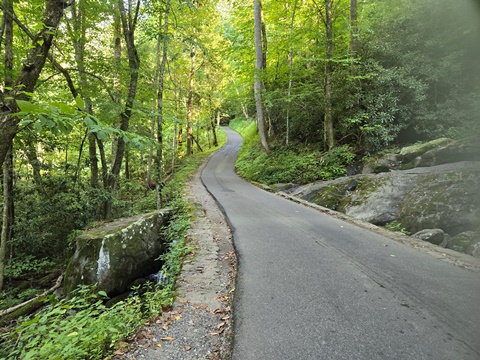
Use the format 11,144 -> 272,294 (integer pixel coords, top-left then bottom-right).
155,0 -> 171,209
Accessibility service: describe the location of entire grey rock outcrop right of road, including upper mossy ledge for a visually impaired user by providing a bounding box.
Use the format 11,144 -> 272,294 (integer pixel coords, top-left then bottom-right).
286,139 -> 480,257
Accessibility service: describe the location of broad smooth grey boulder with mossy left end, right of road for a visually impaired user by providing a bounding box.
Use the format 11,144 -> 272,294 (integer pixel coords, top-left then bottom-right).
288,161 -> 480,254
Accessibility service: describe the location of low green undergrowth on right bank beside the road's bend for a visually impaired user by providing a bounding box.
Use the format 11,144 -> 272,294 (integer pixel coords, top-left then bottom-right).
230,120 -> 356,185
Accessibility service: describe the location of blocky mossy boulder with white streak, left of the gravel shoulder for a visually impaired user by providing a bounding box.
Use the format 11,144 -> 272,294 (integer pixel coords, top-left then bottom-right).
64,209 -> 171,295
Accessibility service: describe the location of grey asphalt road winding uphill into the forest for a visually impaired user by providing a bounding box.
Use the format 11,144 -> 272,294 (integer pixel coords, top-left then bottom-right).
202,129 -> 480,360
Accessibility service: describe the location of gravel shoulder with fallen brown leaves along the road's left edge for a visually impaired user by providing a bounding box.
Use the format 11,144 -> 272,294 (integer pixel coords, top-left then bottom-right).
112,160 -> 236,360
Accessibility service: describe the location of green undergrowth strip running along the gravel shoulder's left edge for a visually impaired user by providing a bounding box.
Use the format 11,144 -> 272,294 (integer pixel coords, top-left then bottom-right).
0,136 -> 224,360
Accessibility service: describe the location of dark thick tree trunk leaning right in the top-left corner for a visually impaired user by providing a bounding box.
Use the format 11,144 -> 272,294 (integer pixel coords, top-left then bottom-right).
0,0 -> 68,166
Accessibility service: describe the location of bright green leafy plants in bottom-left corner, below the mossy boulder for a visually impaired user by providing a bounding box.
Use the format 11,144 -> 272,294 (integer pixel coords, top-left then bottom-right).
0,287 -> 167,360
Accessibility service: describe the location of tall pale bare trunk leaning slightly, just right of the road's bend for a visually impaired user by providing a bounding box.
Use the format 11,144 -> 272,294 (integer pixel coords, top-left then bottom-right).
253,0 -> 270,153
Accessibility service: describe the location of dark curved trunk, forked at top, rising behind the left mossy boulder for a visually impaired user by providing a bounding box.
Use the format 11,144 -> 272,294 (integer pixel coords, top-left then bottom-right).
104,0 -> 141,220
